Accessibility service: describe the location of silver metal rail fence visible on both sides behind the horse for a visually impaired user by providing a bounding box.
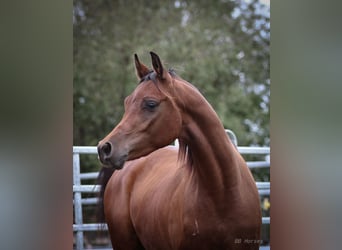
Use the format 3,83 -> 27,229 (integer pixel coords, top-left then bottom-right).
73,146 -> 270,250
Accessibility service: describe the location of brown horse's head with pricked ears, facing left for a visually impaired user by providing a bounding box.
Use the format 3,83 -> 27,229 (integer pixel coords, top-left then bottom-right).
98,52 -> 182,169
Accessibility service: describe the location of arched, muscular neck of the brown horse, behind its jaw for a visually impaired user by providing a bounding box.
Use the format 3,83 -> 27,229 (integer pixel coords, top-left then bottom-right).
175,81 -> 242,198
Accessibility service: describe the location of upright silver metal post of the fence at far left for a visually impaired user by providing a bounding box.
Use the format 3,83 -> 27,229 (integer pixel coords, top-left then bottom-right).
73,153 -> 83,250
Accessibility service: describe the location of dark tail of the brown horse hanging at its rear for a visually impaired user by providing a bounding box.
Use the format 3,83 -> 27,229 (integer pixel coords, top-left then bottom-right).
96,167 -> 115,223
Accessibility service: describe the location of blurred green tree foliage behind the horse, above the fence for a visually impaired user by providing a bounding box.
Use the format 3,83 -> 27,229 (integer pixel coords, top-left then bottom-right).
73,0 -> 270,172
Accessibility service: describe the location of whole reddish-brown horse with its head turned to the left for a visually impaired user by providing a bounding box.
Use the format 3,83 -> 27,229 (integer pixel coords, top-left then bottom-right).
98,52 -> 261,250
